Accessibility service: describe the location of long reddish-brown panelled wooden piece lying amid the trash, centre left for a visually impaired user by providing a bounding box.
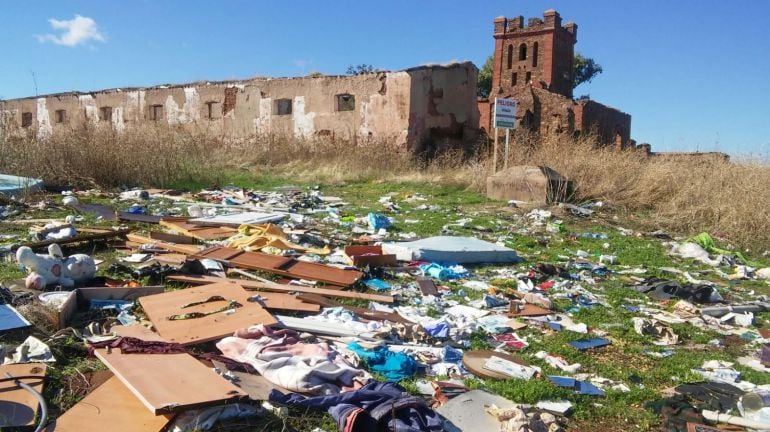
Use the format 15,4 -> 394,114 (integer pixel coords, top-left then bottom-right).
198,247 -> 363,287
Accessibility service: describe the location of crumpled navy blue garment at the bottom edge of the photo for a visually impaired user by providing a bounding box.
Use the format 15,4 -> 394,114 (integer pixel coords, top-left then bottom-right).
270,382 -> 443,432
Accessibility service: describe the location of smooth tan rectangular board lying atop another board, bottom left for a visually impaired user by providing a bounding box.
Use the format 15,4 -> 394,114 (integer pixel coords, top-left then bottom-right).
94,349 -> 247,415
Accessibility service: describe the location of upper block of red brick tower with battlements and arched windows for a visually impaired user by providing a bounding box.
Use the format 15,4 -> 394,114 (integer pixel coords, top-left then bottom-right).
490,9 -> 577,98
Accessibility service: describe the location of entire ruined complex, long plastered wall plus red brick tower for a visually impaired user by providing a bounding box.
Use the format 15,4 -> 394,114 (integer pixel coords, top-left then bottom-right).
0,10 -> 633,152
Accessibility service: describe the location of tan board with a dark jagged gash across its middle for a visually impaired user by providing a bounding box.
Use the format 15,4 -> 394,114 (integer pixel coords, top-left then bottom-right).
139,282 -> 277,345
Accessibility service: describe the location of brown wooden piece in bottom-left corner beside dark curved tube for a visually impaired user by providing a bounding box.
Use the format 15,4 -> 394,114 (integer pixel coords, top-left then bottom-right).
0,363 -> 46,429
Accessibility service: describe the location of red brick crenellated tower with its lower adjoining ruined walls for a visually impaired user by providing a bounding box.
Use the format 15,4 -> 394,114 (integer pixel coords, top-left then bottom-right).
478,10 -> 635,149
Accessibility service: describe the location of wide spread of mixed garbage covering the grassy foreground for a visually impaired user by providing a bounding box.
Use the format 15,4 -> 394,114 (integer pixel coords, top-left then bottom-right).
0,186 -> 770,432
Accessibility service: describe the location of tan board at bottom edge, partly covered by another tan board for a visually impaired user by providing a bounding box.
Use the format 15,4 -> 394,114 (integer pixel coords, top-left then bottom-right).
47,376 -> 174,432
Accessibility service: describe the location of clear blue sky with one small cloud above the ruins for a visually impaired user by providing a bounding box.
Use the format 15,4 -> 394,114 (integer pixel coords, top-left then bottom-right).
0,0 -> 770,157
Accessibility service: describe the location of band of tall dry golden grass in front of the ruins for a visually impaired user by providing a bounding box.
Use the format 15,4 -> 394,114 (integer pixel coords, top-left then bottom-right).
0,123 -> 770,248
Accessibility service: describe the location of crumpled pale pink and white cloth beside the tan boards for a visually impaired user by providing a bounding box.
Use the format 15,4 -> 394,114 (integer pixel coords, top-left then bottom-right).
217,325 -> 370,394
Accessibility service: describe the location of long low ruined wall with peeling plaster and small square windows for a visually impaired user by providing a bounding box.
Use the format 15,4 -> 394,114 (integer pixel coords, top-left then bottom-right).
0,63 -> 478,150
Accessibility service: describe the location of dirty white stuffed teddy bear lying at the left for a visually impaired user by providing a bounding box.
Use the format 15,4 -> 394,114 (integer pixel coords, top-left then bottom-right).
16,244 -> 96,290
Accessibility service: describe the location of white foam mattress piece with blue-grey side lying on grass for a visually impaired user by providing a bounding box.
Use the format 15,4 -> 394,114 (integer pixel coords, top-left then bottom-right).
382,236 -> 520,264
